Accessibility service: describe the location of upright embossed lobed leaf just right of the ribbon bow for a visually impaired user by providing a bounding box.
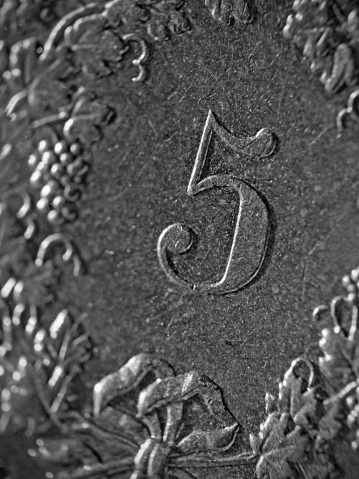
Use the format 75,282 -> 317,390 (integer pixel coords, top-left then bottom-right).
250,358 -> 338,479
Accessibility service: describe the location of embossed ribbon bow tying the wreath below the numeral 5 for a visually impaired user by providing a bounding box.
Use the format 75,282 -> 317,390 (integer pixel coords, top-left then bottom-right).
39,354 -> 243,478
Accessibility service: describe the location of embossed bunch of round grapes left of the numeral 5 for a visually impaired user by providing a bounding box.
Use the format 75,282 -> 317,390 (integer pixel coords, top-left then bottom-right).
28,140 -> 89,224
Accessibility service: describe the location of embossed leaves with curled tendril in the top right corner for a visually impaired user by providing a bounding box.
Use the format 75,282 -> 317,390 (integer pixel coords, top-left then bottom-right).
283,0 -> 359,125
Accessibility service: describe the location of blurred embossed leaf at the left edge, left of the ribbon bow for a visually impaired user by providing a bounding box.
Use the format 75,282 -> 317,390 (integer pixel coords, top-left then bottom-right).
0,305 -> 92,434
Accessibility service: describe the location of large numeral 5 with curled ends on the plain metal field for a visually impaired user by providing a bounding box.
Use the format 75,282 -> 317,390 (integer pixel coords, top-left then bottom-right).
157,111 -> 276,294
